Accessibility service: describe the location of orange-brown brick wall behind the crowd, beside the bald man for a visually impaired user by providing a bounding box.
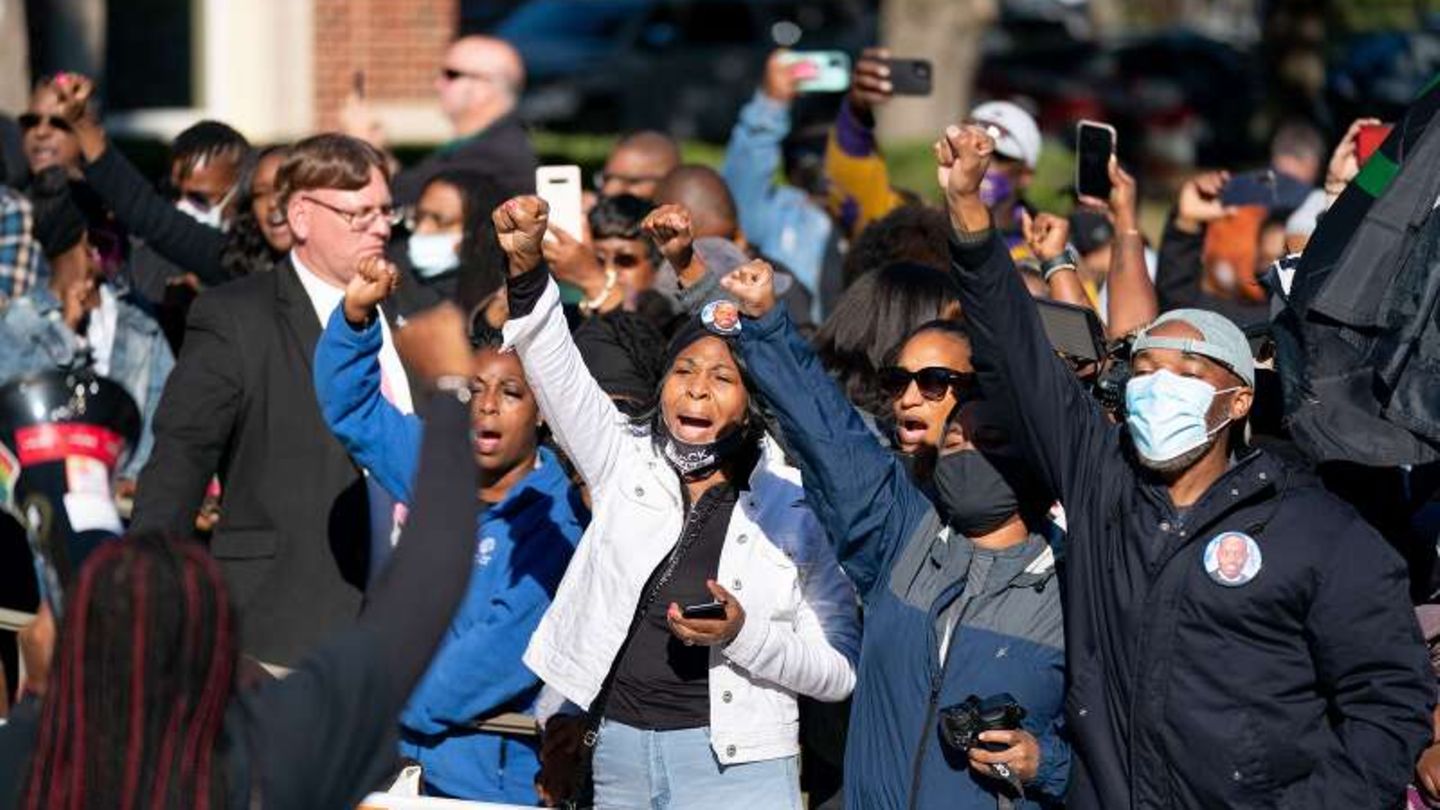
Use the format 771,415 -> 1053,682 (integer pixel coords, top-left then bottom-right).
314,0 -> 459,130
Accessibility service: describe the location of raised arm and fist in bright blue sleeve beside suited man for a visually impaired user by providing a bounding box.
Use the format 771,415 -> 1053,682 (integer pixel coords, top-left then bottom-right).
314,257 -> 420,503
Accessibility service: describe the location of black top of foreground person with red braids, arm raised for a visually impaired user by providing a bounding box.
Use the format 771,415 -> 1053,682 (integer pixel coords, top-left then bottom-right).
0,396 -> 478,810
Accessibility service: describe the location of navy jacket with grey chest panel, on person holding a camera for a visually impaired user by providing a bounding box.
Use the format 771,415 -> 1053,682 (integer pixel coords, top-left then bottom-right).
740,307 -> 1070,810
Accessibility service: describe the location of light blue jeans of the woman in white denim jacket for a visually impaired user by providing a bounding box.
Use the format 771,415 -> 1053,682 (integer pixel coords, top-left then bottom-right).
595,721 -> 801,810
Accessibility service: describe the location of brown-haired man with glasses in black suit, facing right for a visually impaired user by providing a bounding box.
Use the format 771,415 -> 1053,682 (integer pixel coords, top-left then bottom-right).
135,134 -> 426,664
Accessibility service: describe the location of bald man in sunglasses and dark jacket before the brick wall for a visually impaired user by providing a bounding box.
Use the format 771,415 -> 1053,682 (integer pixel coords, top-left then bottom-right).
393,36 -> 539,205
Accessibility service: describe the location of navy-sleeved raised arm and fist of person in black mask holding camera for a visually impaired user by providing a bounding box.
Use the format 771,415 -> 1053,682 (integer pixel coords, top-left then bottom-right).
723,261 -> 930,594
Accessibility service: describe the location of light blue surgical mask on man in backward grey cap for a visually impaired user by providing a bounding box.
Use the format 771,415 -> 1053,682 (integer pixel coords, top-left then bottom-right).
1125,369 -> 1238,464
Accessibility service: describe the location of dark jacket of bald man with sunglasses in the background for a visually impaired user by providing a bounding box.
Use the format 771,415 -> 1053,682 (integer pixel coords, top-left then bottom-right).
392,112 -> 539,205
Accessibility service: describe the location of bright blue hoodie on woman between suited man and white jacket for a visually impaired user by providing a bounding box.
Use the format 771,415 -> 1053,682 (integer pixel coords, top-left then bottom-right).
314,308 -> 589,804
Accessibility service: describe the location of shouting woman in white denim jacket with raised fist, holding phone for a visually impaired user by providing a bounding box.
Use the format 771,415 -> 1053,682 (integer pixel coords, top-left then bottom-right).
494,197 -> 860,810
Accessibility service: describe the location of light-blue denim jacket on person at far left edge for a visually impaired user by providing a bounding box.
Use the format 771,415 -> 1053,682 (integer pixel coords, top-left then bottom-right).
0,284 -> 176,479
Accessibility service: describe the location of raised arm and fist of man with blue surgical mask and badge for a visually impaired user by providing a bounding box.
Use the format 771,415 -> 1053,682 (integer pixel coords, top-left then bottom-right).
935,127 -> 1119,503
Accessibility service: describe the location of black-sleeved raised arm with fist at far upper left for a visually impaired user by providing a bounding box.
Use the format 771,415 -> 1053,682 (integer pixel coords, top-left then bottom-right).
56,76 -> 229,285
